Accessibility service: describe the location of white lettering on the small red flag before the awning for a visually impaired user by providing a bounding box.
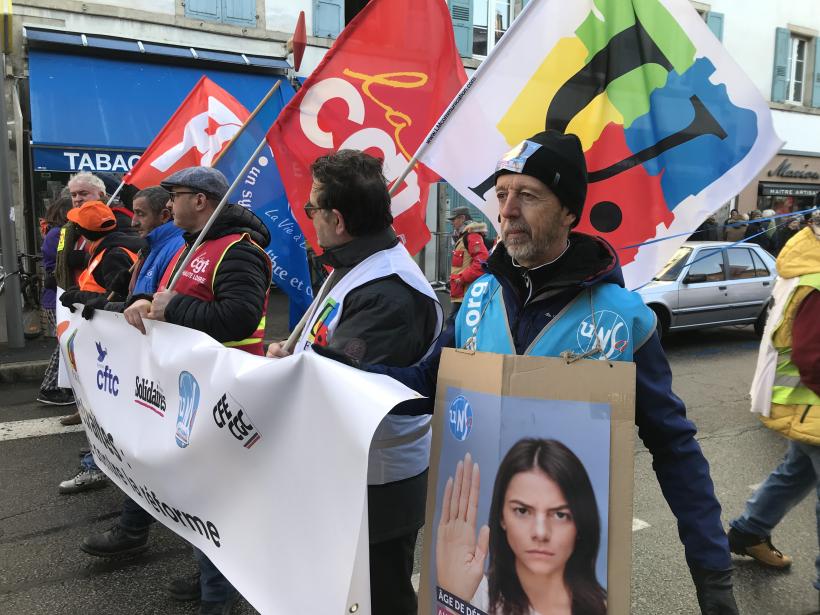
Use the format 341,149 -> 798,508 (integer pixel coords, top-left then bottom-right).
151,96 -> 243,173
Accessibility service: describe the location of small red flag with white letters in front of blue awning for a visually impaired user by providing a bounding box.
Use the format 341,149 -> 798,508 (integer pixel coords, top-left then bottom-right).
123,75 -> 250,188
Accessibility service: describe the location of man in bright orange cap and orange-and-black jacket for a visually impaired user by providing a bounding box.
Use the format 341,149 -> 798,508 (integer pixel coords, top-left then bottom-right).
60,201 -> 144,493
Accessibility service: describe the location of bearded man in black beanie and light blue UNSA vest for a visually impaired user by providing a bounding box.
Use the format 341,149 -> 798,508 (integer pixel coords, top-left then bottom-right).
319,131 -> 737,615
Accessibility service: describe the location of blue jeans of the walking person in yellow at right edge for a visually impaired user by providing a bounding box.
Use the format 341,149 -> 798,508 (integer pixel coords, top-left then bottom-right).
729,440 -> 820,590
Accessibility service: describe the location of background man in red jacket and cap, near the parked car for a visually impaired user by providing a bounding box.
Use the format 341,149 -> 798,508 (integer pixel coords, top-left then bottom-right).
447,207 -> 488,312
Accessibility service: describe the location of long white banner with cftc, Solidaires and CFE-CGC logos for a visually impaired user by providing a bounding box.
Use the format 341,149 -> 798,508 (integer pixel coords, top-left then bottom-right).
58,305 -> 418,615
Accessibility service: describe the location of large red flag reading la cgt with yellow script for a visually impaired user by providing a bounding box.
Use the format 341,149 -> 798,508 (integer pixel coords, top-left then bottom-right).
268,0 -> 467,254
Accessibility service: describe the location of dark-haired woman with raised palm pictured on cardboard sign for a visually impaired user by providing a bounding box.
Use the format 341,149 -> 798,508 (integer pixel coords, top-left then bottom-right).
436,438 -> 606,615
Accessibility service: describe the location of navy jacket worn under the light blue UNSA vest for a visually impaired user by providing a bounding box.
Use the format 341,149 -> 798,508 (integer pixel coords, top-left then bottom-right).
372,233 -> 731,570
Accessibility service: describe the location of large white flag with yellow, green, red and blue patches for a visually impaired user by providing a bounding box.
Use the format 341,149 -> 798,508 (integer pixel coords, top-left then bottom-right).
419,0 -> 782,288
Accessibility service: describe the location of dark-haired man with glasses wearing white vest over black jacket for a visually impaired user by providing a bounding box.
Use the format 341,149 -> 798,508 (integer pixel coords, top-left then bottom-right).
268,150 -> 442,615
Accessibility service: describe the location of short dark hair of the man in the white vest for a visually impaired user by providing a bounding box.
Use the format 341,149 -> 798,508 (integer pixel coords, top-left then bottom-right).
310,149 -> 393,237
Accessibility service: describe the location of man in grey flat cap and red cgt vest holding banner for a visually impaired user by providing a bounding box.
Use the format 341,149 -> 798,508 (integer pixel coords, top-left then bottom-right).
125,167 -> 272,615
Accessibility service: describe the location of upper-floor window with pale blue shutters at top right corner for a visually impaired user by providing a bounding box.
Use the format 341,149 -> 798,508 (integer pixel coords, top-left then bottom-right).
772,28 -> 820,107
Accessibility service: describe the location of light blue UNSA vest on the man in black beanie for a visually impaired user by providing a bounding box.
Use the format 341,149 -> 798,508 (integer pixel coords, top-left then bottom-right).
456,274 -> 655,361
